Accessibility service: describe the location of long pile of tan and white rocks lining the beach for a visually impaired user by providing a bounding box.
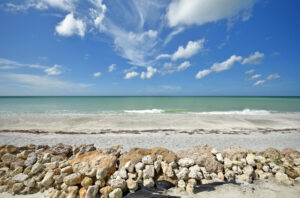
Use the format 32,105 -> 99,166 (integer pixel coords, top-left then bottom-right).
0,144 -> 300,198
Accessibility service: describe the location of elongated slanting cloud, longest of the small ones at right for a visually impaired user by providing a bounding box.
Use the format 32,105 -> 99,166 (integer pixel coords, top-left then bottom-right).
196,55 -> 243,79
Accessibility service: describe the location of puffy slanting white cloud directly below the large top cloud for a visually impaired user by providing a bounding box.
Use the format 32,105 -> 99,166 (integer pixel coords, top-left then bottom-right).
171,39 -> 205,61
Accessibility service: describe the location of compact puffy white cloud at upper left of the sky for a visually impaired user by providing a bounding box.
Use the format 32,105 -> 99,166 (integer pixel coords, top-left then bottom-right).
55,13 -> 86,37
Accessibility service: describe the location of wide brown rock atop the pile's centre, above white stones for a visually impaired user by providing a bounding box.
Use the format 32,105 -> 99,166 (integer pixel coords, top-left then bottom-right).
120,147 -> 177,168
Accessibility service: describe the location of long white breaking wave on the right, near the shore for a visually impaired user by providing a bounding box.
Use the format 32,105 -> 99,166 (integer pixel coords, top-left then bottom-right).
193,109 -> 271,115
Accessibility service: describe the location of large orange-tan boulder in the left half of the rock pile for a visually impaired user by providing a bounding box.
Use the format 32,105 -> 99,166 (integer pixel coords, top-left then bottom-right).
70,151 -> 117,176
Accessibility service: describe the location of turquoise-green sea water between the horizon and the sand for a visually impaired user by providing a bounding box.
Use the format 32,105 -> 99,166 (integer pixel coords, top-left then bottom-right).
0,96 -> 300,114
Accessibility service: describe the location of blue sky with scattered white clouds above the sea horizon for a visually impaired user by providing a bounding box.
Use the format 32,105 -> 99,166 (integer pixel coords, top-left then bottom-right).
0,0 -> 300,96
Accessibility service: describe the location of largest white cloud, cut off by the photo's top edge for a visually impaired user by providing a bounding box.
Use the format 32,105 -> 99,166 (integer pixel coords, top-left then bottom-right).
167,0 -> 256,27
